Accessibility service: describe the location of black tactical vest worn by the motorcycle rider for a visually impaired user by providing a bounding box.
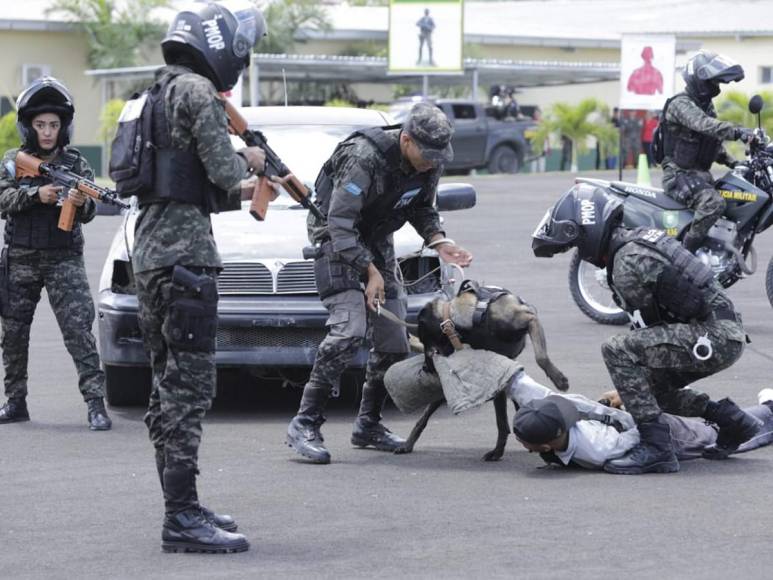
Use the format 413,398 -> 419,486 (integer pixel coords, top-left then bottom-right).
660,93 -> 722,171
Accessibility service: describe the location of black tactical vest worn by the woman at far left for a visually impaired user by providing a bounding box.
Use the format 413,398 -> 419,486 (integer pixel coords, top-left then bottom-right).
5,149 -> 83,250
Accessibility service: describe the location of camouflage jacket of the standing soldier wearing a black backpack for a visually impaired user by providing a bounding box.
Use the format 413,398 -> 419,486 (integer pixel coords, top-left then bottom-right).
132,66 -> 248,272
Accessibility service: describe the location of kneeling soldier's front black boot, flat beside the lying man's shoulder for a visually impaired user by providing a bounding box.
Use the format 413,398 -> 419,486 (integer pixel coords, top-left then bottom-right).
604,417 -> 679,475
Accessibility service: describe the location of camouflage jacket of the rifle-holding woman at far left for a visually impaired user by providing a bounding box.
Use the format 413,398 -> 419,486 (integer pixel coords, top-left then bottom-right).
0,146 -> 97,223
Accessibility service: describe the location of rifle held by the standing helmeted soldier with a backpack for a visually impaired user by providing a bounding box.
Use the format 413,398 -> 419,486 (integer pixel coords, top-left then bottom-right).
223,98 -> 325,221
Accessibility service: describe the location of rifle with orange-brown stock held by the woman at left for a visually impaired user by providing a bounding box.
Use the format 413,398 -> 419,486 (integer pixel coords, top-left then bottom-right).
16,151 -> 129,232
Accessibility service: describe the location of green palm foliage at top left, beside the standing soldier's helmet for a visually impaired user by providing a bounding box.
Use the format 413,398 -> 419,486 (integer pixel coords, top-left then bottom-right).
46,0 -> 170,68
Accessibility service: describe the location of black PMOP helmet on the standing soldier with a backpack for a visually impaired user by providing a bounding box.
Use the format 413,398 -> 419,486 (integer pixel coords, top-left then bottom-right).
161,0 -> 266,92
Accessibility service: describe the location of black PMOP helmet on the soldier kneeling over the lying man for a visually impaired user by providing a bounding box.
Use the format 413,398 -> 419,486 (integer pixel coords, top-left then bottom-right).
531,183 -> 623,268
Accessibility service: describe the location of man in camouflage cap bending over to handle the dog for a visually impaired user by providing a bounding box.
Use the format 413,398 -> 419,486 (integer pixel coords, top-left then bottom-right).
287,103 -> 472,463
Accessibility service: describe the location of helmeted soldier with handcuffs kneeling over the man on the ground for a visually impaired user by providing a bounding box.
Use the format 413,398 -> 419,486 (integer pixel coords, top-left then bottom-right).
532,184 -> 759,474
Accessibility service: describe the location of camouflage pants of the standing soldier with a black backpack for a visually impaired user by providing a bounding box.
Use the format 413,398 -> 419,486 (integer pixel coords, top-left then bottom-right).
135,268 -> 217,470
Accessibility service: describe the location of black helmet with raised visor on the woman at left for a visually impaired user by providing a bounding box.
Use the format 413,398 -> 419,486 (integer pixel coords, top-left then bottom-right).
16,77 -> 75,151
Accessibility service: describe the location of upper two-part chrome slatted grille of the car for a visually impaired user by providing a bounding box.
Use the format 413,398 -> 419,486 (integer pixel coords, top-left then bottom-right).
217,262 -> 317,296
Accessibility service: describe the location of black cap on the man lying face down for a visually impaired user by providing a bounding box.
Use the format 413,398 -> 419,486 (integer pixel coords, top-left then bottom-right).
513,395 -> 580,445
